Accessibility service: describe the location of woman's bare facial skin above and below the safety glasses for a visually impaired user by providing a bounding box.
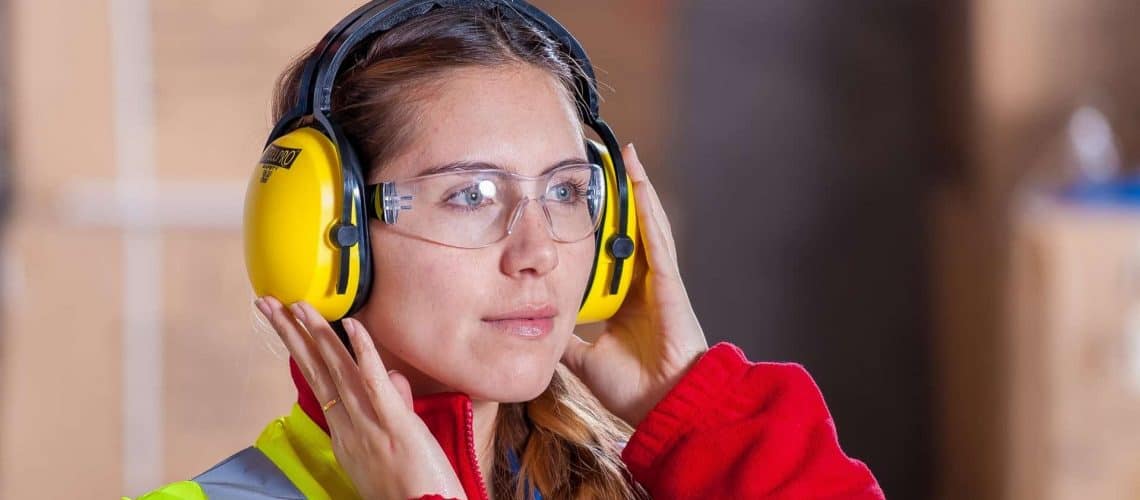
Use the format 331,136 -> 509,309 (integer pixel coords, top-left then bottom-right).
356,65 -> 594,402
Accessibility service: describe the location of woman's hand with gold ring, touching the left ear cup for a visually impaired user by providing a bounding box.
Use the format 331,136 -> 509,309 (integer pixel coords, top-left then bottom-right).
255,297 -> 466,500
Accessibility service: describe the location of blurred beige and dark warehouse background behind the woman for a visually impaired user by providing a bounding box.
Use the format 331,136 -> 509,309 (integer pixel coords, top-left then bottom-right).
0,0 -> 1140,499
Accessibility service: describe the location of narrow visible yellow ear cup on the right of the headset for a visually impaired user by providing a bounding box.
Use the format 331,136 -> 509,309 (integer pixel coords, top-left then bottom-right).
578,140 -> 641,325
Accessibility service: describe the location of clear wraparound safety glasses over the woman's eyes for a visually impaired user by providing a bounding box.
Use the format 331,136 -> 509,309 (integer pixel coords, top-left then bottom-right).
377,164 -> 605,248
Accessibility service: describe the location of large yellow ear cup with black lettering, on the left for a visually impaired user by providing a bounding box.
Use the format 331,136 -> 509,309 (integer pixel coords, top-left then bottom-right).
244,128 -> 360,320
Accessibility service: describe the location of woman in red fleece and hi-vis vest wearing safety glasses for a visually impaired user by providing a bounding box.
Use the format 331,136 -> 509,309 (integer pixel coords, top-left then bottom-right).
133,1 -> 882,499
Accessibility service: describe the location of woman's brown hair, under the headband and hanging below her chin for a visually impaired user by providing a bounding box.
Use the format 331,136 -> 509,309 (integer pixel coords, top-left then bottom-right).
274,7 -> 648,500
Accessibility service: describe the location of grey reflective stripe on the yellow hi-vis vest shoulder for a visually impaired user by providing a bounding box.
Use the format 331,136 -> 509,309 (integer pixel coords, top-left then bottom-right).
194,446 -> 304,500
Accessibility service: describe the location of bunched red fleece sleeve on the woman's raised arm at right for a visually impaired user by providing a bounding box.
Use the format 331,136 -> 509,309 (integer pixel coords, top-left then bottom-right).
621,342 -> 884,499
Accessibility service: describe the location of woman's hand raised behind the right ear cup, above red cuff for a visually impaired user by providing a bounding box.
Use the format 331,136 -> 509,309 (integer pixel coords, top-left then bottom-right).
562,145 -> 708,427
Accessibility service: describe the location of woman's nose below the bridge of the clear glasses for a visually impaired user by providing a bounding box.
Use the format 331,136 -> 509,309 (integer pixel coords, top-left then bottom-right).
503,198 -> 559,276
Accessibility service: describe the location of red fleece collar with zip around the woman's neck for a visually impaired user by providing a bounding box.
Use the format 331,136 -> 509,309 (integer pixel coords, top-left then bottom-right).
288,359 -> 487,499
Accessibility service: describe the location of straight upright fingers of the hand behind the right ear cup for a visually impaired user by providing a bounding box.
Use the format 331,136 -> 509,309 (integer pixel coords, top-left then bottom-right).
622,144 -> 681,277
